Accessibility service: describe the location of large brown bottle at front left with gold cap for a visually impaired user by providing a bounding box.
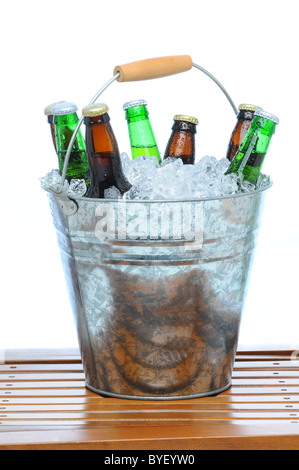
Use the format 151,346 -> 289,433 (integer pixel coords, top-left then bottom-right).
82,103 -> 131,198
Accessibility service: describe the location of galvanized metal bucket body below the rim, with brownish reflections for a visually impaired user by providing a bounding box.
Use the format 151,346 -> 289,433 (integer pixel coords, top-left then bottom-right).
49,188 -> 267,400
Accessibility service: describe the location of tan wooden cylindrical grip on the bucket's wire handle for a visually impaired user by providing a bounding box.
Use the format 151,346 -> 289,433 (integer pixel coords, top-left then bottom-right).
114,55 -> 192,82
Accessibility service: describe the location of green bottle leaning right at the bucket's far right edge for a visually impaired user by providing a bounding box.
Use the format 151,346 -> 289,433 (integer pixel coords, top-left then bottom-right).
226,109 -> 279,186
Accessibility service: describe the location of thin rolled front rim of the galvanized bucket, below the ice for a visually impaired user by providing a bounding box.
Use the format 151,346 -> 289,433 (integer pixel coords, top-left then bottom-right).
68,180 -> 273,204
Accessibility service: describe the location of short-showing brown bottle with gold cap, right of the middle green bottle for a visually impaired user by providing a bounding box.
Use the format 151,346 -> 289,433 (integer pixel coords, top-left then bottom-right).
164,114 -> 198,165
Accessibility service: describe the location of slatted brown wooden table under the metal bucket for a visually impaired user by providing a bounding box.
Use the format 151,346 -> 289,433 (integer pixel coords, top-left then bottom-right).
0,350 -> 299,454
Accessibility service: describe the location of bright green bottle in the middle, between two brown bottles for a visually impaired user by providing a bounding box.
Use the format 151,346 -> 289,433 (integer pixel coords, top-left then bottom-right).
123,100 -> 161,163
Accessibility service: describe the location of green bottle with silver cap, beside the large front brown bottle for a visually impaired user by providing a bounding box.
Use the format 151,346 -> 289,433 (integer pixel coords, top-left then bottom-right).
52,102 -> 90,185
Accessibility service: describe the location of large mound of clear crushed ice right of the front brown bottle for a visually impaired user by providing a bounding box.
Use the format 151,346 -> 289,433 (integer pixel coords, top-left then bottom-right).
121,153 -> 270,199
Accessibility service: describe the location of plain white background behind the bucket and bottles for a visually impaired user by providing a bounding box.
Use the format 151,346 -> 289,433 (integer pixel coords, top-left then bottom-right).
0,0 -> 299,349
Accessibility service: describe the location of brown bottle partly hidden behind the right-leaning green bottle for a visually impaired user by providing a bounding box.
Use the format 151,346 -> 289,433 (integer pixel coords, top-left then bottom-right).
226,104 -> 261,162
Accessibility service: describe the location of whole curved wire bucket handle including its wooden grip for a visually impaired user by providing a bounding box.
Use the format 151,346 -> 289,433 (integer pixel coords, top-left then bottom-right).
49,55 -> 238,215
